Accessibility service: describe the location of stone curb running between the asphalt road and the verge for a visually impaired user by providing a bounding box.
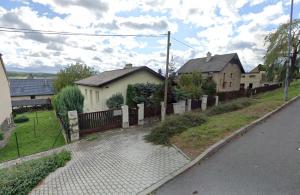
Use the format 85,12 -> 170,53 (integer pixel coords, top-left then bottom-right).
138,96 -> 300,195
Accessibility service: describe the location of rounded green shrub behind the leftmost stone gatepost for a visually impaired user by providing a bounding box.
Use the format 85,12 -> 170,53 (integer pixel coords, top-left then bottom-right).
52,86 -> 84,119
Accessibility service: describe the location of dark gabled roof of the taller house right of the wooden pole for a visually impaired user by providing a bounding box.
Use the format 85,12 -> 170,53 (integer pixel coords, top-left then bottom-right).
177,53 -> 245,73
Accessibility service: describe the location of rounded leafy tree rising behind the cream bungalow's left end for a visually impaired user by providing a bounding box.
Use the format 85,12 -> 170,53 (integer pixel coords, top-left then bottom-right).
54,63 -> 96,93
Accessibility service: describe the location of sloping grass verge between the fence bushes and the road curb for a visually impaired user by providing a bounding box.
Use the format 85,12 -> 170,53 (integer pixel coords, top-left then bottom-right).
171,82 -> 300,158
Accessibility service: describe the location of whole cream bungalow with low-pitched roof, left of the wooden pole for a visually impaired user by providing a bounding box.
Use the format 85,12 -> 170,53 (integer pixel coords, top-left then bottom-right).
75,64 -> 164,112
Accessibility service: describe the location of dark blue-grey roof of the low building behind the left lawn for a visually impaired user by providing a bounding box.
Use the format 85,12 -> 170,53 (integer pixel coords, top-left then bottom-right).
10,79 -> 54,97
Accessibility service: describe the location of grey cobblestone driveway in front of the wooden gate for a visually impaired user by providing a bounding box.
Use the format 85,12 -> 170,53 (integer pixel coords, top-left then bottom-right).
31,129 -> 189,194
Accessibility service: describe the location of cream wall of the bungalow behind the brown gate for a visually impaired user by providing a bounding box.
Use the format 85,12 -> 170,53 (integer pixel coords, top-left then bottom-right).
78,71 -> 163,112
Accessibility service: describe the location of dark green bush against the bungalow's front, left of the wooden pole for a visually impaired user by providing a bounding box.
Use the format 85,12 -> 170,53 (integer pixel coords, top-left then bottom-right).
126,83 -> 161,106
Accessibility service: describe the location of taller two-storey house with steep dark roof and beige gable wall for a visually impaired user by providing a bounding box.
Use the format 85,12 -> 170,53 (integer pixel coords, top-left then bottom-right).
177,52 -> 245,92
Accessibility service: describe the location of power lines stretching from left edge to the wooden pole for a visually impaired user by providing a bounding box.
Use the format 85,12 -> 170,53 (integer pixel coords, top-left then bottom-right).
0,26 -> 167,37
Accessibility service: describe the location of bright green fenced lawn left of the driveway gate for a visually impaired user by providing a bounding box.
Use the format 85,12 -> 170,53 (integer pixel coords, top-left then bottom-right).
0,111 -> 65,162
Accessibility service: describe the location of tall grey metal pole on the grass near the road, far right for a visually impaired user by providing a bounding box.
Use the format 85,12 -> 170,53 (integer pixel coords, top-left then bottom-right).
284,0 -> 294,101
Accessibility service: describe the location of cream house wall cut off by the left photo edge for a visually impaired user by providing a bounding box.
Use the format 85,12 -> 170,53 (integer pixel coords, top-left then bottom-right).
0,54 -> 12,131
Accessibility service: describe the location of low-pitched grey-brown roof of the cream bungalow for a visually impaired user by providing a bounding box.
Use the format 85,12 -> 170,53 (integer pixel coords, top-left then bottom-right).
75,66 -> 164,87
